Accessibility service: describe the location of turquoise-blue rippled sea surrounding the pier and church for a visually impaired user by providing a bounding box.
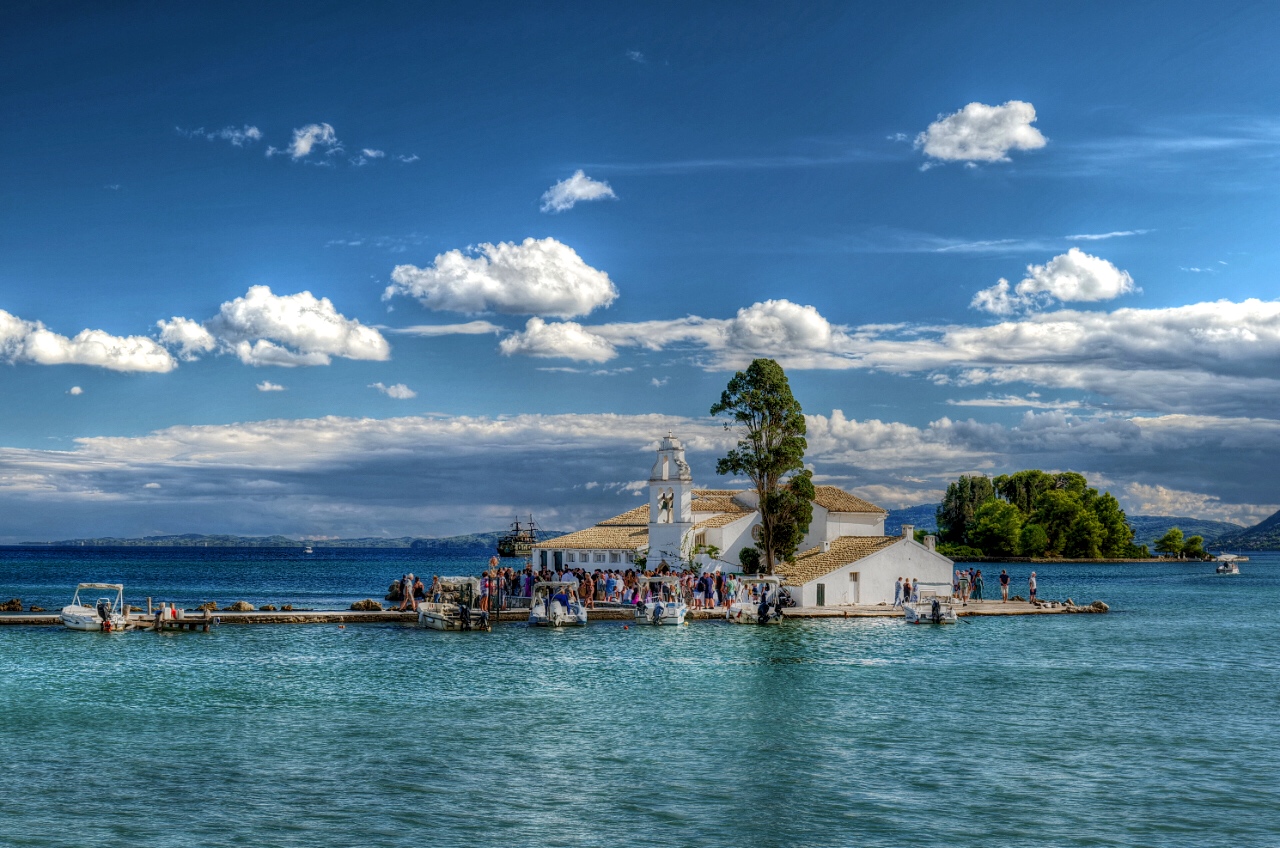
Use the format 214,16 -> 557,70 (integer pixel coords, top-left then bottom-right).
0,550 -> 1280,848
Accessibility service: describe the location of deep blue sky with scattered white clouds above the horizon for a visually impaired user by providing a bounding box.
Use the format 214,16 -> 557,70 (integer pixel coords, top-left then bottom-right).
0,3 -> 1280,539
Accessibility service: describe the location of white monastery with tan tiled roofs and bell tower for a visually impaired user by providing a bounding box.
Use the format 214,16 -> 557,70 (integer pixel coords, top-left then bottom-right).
532,436 -> 955,607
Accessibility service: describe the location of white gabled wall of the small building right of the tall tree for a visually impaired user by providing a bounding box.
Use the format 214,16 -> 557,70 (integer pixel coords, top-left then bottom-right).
791,539 -> 955,607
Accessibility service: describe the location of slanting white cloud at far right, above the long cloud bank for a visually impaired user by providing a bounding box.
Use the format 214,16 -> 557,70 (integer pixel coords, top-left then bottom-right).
970,247 -> 1140,315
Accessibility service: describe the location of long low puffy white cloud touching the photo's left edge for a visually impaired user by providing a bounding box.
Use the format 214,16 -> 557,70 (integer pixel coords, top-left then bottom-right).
0,309 -> 178,373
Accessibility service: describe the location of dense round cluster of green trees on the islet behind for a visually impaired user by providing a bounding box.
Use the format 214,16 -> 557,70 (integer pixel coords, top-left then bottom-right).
937,469 -> 1147,559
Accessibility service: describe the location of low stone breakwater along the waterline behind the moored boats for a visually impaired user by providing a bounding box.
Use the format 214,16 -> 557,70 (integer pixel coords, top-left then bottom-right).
0,598 -> 1111,628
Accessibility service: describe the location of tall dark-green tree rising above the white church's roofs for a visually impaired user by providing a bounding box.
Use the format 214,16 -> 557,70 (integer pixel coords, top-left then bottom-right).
712,359 -> 809,574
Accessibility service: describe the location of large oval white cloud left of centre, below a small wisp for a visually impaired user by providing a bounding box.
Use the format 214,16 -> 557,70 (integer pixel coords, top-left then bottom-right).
383,238 -> 618,318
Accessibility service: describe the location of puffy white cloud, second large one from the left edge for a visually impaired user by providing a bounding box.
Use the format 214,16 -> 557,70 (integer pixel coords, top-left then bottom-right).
206,286 -> 390,366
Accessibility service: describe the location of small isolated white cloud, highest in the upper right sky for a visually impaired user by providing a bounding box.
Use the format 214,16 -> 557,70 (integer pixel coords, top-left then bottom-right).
915,100 -> 1046,163
